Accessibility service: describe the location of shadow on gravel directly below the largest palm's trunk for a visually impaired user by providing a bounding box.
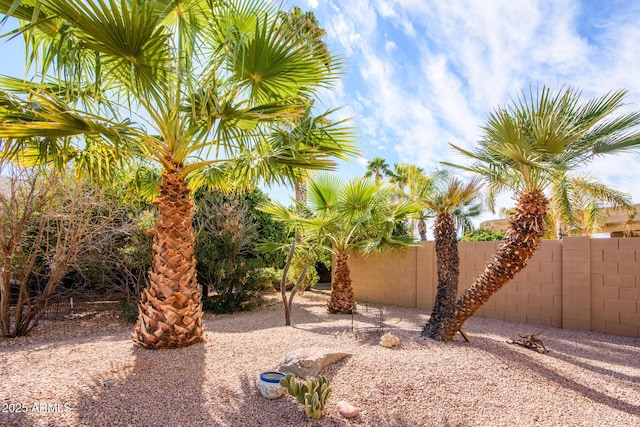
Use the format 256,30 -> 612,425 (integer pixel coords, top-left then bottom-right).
78,343 -> 215,426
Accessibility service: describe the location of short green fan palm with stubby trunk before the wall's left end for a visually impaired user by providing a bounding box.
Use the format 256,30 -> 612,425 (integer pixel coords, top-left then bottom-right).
261,174 -> 418,313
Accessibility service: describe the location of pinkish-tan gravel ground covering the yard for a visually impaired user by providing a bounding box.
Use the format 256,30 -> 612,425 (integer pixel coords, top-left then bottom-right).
0,292 -> 640,426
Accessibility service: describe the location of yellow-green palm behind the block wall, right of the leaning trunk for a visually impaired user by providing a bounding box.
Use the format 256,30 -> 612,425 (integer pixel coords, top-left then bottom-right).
547,173 -> 636,238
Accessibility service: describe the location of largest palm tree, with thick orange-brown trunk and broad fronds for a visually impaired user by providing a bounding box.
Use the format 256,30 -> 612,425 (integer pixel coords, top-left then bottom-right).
0,0 -> 356,348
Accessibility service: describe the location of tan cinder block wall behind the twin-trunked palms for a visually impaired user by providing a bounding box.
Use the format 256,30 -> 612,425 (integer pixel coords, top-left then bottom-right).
349,237 -> 640,337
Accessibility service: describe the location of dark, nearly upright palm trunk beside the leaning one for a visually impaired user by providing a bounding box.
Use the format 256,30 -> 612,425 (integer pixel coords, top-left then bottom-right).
422,213 -> 460,341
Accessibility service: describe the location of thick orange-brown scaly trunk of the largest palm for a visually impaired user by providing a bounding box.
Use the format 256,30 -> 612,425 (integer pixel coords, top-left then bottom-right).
133,172 -> 203,348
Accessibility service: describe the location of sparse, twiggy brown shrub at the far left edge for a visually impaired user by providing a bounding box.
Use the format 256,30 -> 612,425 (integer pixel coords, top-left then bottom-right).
0,168 -> 120,337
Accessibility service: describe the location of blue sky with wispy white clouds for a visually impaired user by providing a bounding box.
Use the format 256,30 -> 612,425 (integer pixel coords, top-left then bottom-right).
0,0 -> 640,229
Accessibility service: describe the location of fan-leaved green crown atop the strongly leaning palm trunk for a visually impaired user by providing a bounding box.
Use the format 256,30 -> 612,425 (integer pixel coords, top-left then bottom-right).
445,87 -> 640,207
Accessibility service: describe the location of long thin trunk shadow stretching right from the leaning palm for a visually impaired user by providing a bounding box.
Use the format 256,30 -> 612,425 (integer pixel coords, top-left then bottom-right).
473,336 -> 640,415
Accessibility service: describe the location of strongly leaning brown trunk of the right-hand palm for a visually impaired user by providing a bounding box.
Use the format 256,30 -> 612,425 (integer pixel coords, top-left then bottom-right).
442,190 -> 549,341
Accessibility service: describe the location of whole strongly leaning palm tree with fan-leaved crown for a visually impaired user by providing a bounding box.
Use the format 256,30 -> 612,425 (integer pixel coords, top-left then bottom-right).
442,87 -> 640,340
